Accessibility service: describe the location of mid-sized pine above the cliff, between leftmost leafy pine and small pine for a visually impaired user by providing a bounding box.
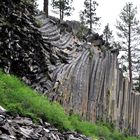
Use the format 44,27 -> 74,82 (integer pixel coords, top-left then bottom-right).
80,0 -> 100,31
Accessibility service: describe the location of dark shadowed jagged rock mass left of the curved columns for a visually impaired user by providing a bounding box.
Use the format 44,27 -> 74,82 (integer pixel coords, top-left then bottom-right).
0,0 -> 47,88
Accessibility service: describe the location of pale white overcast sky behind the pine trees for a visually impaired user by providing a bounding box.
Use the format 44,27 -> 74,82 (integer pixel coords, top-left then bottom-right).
37,0 -> 140,34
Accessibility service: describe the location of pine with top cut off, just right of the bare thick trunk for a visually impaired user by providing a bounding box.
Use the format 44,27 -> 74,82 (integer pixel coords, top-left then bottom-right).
52,0 -> 74,21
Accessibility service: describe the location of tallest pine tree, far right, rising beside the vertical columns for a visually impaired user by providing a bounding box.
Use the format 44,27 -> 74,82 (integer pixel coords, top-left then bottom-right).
116,3 -> 140,85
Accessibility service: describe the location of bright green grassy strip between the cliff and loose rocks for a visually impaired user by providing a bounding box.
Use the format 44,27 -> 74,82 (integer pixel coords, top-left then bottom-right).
0,71 -> 138,140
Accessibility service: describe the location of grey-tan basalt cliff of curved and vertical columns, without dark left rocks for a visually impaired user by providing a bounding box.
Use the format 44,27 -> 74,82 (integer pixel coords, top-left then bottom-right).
35,15 -> 140,135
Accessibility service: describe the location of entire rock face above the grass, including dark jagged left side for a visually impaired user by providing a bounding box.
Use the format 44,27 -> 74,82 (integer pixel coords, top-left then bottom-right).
0,0 -> 140,135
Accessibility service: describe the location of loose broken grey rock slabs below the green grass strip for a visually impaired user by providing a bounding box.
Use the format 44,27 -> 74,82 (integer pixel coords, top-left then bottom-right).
0,106 -> 92,140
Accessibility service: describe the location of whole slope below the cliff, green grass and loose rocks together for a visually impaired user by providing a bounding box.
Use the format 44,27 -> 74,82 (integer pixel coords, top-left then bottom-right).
0,72 -> 137,140
